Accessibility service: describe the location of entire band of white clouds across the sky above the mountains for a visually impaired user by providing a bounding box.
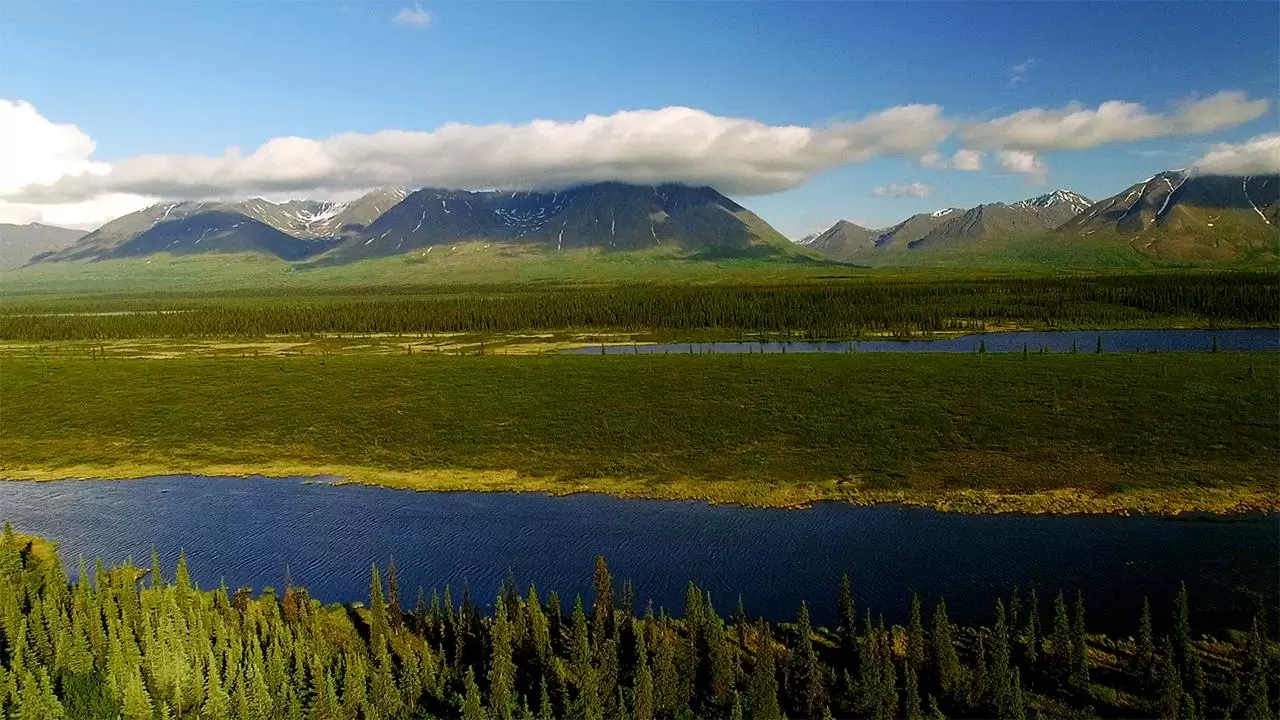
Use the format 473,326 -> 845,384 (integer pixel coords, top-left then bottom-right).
0,91 -> 1280,227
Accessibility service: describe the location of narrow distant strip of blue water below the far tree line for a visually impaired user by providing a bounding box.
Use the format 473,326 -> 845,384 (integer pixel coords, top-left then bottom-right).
564,328 -> 1280,355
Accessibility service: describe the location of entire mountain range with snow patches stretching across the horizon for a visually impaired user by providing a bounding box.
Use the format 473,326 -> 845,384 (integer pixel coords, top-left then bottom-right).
10,170 -> 1280,266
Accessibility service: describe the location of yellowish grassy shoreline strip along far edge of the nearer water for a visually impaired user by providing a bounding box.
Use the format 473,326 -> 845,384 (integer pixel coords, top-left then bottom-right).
0,462 -> 1280,518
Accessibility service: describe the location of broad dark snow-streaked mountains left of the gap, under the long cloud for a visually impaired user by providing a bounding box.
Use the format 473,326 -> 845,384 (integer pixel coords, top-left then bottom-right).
42,182 -> 796,264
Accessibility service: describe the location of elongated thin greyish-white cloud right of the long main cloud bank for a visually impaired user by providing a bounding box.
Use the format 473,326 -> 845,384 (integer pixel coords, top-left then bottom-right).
960,91 -> 1267,152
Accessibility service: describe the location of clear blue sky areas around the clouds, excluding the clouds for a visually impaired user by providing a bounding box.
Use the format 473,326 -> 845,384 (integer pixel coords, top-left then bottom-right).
0,0 -> 1280,234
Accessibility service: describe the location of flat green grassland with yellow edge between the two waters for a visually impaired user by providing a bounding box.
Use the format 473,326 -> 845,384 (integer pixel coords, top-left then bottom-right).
0,354 -> 1280,512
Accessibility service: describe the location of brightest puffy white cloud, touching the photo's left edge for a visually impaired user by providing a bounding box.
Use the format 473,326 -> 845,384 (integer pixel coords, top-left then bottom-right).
0,99 -> 152,228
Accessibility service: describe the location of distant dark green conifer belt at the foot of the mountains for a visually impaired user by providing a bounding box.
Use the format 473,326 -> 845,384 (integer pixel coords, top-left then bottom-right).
0,273 -> 1280,342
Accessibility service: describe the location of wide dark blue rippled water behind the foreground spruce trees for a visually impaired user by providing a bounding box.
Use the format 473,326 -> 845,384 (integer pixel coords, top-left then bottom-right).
0,477 -> 1280,634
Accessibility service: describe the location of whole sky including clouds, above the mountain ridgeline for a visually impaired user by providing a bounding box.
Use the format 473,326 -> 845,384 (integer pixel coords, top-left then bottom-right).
0,0 -> 1280,237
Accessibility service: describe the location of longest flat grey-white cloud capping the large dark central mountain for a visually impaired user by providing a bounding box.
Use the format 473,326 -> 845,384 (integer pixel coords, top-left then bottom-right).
5,105 -> 955,202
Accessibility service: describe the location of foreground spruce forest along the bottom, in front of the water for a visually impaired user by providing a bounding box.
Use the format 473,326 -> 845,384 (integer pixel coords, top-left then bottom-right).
0,525 -> 1280,720
